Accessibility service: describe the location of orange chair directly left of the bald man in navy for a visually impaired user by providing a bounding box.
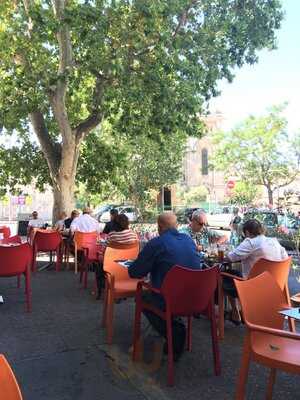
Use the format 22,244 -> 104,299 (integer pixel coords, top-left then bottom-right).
102,242 -> 140,344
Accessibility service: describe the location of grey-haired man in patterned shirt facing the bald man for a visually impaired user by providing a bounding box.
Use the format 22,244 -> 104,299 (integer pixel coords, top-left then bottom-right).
180,210 -> 227,251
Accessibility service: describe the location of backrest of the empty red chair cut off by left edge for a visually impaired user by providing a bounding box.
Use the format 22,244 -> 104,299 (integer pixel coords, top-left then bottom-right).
0,243 -> 32,276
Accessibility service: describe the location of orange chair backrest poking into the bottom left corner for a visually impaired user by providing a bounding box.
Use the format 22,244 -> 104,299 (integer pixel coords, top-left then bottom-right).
0,354 -> 23,400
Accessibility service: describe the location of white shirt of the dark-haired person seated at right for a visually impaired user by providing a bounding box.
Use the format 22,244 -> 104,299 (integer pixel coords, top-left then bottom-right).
228,235 -> 288,277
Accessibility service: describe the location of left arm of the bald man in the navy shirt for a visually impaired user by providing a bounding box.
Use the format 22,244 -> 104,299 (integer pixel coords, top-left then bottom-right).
128,240 -> 157,279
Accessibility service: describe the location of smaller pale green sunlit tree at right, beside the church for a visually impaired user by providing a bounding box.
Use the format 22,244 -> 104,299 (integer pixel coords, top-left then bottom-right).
213,106 -> 300,204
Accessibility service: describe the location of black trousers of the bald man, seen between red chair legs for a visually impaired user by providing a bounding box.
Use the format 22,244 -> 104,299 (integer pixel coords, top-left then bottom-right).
142,292 -> 186,354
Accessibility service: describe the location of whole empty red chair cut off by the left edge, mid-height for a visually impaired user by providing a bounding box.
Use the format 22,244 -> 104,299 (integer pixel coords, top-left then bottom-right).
0,243 -> 32,312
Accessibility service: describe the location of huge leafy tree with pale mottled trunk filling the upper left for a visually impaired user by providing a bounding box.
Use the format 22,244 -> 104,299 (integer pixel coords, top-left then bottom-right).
0,0 -> 283,219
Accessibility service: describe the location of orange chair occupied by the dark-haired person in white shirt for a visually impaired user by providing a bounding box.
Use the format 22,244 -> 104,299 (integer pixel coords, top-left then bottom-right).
218,257 -> 296,339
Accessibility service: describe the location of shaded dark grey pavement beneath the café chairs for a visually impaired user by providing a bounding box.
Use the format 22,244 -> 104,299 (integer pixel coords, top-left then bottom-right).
0,262 -> 300,400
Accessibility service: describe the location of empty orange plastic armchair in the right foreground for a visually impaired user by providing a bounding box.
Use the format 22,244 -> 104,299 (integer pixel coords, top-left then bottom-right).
234,272 -> 300,400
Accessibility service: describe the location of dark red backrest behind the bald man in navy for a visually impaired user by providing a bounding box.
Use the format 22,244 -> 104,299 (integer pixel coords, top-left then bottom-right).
161,265 -> 219,316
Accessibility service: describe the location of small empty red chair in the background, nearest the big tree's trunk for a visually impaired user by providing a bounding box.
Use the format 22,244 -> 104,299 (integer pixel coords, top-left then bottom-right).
32,230 -> 62,272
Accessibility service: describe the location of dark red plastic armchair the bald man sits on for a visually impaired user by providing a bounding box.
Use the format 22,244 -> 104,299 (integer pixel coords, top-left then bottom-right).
133,265 -> 221,385
